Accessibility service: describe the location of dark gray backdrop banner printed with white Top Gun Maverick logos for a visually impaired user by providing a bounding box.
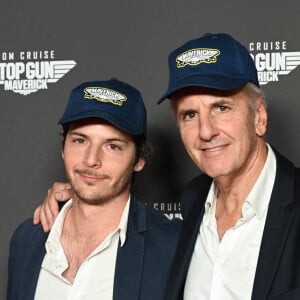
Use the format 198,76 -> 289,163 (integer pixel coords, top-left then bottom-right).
0,0 -> 300,299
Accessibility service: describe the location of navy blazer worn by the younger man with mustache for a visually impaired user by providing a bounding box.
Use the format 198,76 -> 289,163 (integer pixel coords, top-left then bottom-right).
7,197 -> 181,300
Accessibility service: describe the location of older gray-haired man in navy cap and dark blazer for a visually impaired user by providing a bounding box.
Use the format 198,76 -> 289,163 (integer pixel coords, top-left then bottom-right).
159,33 -> 300,300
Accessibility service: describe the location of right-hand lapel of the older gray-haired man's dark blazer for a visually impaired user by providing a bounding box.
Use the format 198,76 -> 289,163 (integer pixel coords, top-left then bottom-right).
251,152 -> 295,300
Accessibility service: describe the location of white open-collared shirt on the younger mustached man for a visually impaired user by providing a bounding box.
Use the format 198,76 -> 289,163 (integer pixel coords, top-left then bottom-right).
34,199 -> 130,300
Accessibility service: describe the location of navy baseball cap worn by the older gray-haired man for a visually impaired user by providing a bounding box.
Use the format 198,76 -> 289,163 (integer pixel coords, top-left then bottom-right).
158,33 -> 259,103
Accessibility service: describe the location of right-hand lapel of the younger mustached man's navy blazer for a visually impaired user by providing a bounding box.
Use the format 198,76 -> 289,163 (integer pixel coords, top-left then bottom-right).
113,198 -> 146,300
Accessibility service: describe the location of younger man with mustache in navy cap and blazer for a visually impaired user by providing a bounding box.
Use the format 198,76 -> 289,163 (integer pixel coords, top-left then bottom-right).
7,79 -> 180,300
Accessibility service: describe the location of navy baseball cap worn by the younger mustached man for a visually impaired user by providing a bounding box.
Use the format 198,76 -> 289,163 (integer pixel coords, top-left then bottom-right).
58,78 -> 147,137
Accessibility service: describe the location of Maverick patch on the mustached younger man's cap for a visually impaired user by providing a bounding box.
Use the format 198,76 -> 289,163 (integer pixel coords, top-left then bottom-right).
84,87 -> 127,106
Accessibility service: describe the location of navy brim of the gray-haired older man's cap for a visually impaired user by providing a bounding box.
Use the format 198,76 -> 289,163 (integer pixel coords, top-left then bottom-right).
157,74 -> 249,104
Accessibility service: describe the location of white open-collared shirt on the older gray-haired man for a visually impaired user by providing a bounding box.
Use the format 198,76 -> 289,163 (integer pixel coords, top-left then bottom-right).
184,145 -> 276,300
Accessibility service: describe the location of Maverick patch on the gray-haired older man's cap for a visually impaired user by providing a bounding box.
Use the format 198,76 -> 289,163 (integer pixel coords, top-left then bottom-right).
176,48 -> 221,68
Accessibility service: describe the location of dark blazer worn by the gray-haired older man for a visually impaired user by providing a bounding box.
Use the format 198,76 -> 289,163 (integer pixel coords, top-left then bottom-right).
165,149 -> 300,300
